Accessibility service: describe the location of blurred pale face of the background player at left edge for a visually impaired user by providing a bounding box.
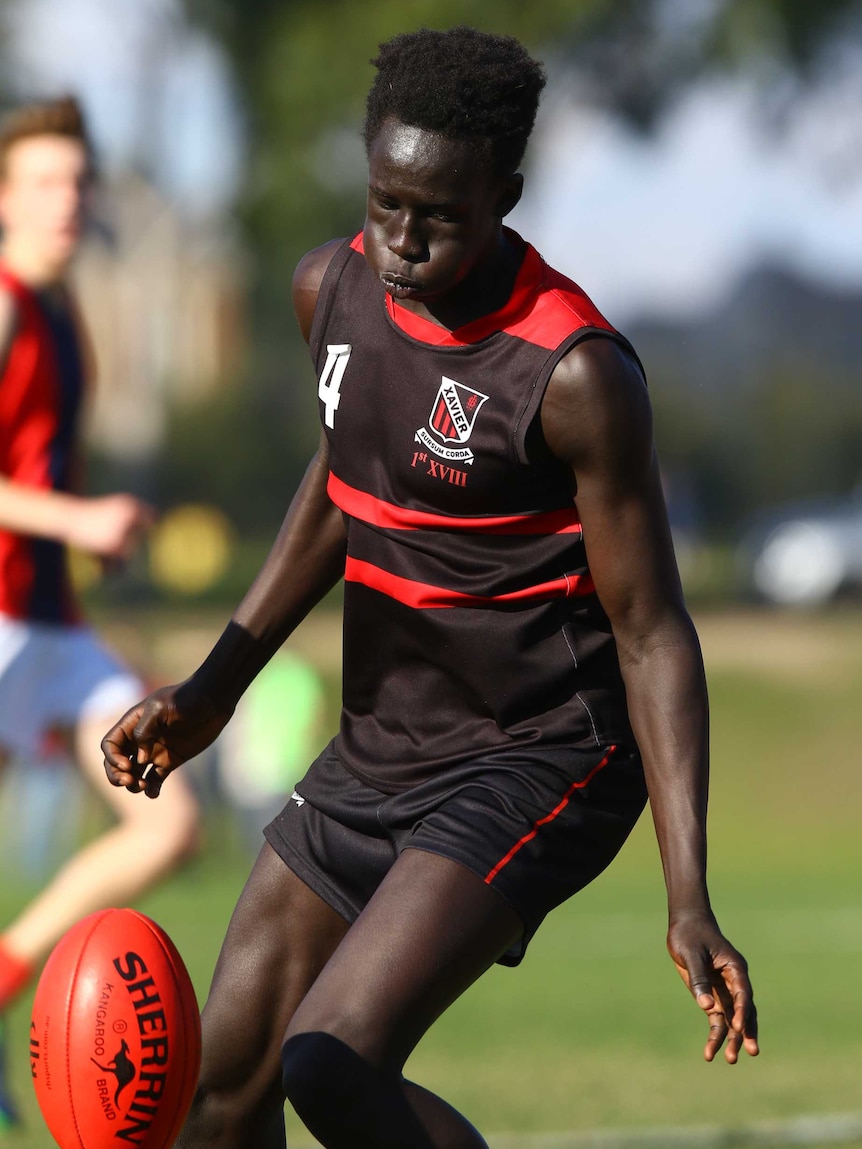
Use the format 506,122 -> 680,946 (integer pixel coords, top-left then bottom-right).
0,136 -> 91,269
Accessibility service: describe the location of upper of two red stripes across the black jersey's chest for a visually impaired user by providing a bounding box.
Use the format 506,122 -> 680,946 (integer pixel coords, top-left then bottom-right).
326,471 -> 580,534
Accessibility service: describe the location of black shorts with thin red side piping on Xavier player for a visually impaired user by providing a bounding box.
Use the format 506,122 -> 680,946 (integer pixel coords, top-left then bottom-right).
264,742 -> 647,965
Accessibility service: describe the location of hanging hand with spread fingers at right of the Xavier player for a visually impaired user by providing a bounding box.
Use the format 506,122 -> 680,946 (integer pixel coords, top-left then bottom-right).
668,913 -> 760,1065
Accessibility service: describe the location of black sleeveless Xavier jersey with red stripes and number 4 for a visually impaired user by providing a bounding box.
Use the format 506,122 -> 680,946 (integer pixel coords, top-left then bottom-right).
310,232 -> 633,793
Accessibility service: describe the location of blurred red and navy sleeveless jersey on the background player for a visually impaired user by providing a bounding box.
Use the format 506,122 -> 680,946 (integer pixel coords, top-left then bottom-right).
0,263 -> 84,623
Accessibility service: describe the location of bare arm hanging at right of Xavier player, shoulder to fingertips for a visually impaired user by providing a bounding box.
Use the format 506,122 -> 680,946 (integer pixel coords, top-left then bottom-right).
541,339 -> 757,1062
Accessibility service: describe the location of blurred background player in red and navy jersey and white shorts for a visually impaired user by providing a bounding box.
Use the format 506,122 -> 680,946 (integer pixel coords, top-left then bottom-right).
0,99 -> 197,1127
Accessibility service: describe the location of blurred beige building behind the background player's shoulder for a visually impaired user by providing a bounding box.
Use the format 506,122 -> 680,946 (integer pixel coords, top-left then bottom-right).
75,173 -> 246,461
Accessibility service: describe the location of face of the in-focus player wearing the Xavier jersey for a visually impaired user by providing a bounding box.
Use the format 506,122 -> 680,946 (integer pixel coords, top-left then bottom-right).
364,118 -> 519,306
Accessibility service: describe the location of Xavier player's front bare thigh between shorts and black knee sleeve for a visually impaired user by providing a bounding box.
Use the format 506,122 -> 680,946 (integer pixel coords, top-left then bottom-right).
285,849 -> 523,1072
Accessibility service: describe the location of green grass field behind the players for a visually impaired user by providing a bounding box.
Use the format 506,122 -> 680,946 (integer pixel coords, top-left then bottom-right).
0,612 -> 862,1149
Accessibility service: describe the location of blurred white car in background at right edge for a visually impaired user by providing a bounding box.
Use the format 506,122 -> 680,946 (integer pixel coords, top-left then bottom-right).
741,492 -> 862,607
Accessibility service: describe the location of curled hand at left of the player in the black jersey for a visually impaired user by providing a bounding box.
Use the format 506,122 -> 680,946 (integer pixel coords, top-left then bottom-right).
102,679 -> 231,797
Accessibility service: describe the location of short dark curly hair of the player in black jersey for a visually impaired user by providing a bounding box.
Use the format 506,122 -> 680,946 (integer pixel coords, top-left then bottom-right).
363,26 -> 545,176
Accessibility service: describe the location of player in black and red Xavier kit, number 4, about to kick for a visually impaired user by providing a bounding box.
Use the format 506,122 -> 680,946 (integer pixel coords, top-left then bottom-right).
102,28 -> 757,1149
